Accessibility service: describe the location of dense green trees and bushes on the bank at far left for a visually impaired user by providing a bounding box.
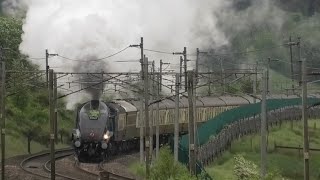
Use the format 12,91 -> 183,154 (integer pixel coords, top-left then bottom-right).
0,17 -> 72,152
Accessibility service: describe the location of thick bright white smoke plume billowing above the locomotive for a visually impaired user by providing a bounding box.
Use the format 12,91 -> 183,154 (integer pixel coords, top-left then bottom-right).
6,0 -> 288,107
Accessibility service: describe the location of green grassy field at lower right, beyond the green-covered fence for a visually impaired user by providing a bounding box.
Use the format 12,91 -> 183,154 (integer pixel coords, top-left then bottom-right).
206,120 -> 320,180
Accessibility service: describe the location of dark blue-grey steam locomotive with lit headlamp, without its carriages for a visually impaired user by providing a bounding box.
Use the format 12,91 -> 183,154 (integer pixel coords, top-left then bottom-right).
72,100 -> 114,162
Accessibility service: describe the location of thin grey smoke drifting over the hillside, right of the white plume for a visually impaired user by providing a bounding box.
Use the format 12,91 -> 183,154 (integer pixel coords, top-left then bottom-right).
200,0 -> 288,72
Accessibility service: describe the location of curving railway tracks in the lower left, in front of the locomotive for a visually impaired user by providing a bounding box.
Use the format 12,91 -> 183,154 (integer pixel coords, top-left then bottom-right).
20,148 -> 133,180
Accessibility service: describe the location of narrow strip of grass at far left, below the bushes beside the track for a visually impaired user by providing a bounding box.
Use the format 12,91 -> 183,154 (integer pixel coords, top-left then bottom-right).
6,135 -> 69,158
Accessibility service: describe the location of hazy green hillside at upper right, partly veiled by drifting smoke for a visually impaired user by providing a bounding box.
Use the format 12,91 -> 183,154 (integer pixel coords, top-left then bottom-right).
200,0 -> 320,92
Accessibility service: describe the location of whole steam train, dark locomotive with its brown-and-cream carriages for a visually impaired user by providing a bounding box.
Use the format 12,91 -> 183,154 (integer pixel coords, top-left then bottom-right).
72,96 -> 253,162
